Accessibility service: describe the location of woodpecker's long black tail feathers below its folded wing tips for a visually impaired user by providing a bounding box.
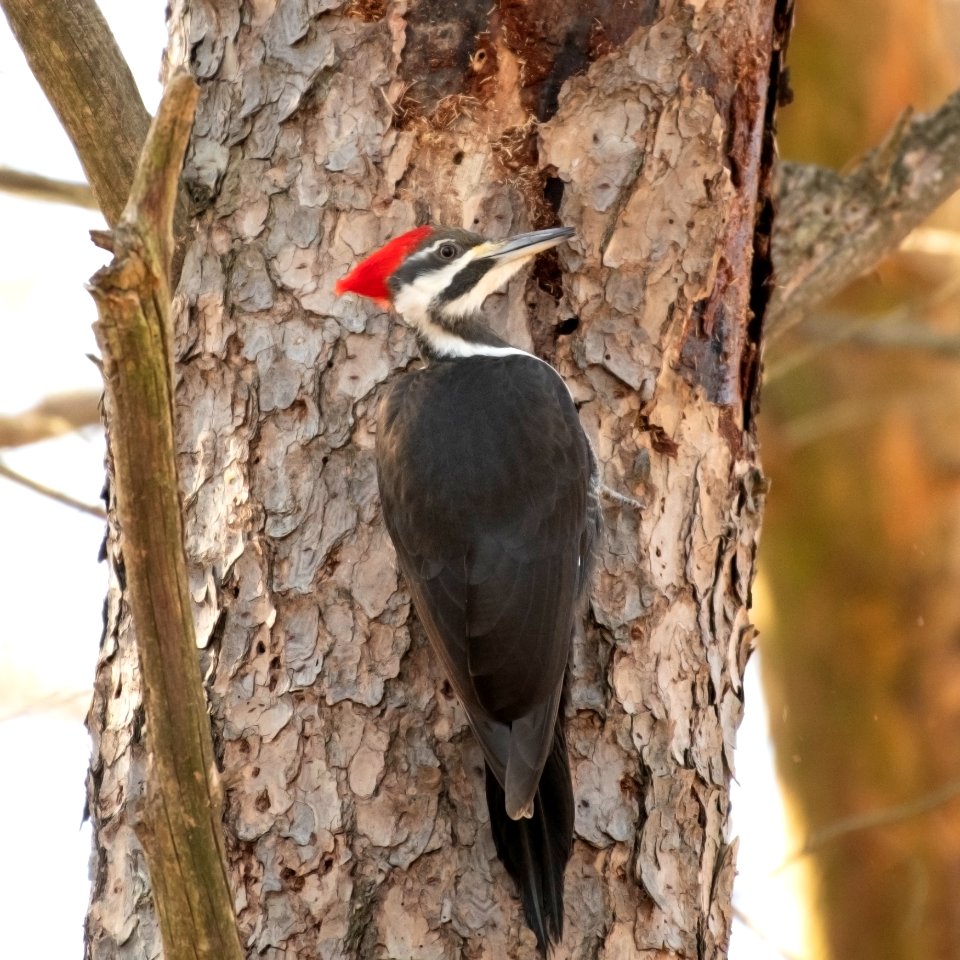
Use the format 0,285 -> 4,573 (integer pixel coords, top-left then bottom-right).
487,711 -> 573,956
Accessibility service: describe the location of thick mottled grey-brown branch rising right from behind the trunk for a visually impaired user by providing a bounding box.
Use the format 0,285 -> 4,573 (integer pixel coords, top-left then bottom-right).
767,91 -> 960,338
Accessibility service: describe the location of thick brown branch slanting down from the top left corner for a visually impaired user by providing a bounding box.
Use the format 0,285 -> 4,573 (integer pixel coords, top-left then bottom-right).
0,0 -> 150,227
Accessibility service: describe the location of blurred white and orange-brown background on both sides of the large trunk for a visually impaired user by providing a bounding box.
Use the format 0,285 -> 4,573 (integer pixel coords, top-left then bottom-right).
0,0 -> 960,960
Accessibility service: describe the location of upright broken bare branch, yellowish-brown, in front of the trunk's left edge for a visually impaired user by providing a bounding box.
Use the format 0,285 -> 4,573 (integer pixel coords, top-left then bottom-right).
90,71 -> 243,960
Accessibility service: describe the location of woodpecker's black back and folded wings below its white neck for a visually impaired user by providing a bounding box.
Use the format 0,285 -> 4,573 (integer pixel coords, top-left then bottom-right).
377,355 -> 593,815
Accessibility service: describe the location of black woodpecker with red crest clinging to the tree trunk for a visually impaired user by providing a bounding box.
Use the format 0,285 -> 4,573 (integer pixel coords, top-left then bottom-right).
336,227 -> 599,953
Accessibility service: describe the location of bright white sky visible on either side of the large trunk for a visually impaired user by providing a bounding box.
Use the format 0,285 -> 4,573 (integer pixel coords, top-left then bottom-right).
0,0 -> 806,960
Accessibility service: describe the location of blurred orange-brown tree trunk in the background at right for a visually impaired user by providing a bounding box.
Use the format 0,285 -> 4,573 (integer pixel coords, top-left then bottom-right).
761,0 -> 960,960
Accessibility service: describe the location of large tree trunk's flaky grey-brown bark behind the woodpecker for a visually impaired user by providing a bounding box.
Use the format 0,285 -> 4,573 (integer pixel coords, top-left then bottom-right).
87,0 -> 789,960
